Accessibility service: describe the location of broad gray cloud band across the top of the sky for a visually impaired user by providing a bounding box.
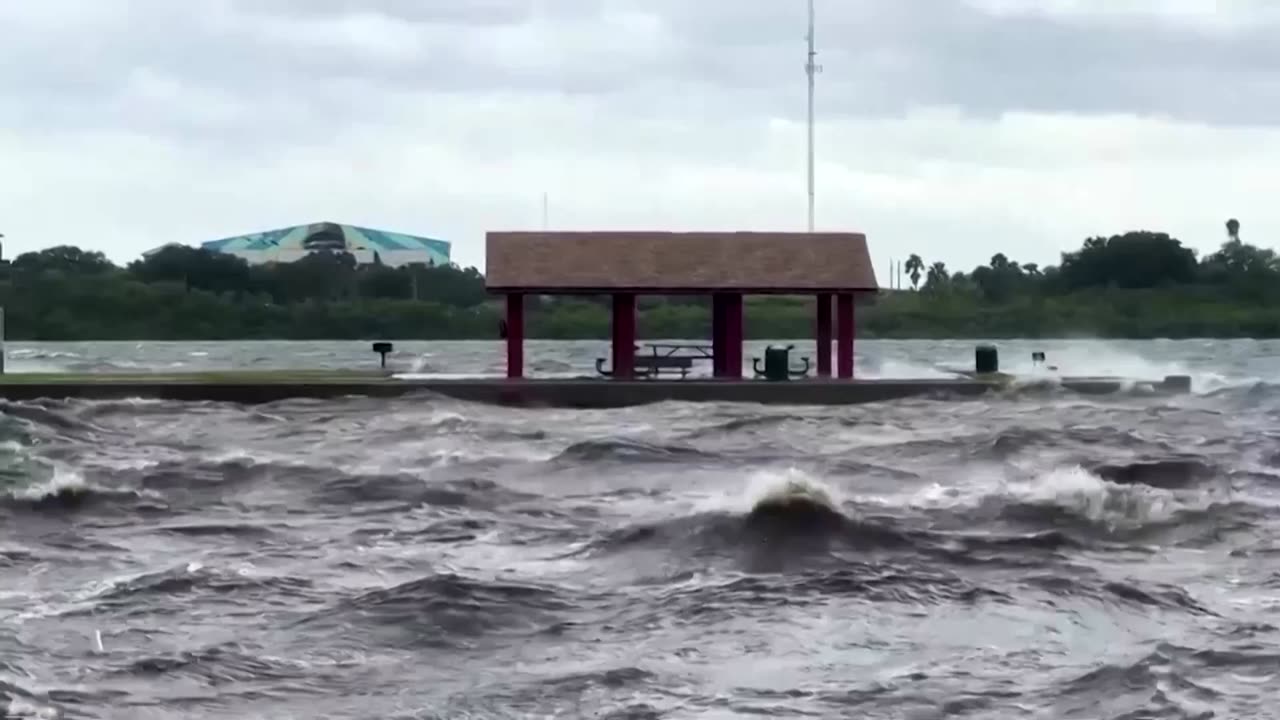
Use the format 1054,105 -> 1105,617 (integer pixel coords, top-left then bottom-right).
10,0 -> 1280,142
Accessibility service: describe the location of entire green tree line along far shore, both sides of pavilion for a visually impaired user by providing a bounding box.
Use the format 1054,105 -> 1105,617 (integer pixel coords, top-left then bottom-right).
0,219 -> 1280,340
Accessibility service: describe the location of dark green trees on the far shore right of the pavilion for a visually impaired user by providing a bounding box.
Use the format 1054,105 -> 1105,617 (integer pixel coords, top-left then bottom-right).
874,218 -> 1280,338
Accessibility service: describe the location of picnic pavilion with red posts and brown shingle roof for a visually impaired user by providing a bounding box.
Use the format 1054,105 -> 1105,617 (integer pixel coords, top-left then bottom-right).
485,232 -> 878,379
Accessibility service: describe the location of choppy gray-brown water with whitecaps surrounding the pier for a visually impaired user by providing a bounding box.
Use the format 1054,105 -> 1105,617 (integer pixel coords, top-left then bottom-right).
0,342 -> 1280,719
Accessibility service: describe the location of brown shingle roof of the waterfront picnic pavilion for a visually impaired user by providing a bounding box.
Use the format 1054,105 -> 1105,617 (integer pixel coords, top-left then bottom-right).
485,232 -> 878,292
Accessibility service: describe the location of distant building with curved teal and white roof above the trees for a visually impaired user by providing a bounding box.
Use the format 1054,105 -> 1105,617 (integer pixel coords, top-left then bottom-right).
192,223 -> 449,266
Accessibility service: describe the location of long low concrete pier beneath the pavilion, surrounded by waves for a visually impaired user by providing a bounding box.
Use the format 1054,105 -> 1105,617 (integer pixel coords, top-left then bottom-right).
0,372 -> 1190,409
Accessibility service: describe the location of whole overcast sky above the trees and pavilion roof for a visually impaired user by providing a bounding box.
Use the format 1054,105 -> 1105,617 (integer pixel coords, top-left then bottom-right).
0,0 -> 1280,278
